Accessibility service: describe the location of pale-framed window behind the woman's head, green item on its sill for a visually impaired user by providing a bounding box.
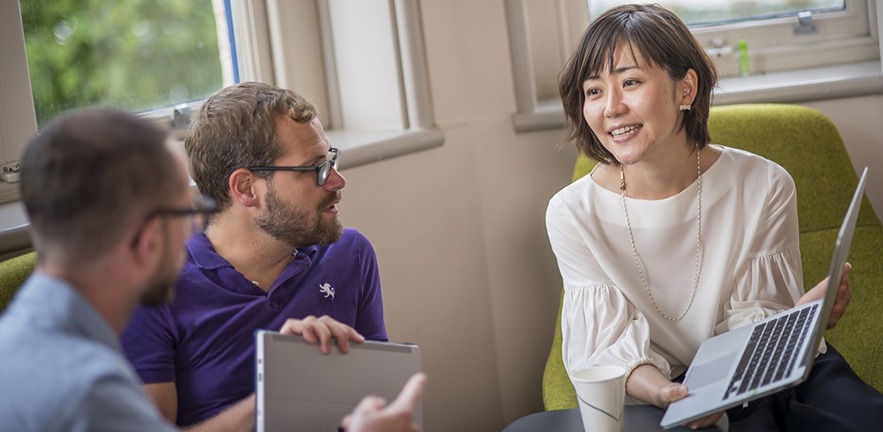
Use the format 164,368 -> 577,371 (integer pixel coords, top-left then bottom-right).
506,0 -> 881,131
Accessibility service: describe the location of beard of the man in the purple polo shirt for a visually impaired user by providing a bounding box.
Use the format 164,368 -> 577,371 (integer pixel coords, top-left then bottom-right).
255,187 -> 343,248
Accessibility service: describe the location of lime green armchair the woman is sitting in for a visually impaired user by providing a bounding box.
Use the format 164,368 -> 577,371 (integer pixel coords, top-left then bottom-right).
543,104 -> 883,410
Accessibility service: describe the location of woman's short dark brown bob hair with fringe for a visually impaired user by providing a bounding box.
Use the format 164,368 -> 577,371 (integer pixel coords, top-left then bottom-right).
558,5 -> 717,164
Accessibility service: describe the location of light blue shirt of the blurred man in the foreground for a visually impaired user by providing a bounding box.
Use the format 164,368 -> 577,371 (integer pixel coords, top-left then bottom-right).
0,273 -> 174,431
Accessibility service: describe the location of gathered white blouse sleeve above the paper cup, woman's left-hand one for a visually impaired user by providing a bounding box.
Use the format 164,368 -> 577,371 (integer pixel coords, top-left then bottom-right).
561,285 -> 671,379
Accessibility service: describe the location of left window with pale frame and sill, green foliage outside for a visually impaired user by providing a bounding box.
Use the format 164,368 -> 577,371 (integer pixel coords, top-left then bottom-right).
0,0 -> 443,202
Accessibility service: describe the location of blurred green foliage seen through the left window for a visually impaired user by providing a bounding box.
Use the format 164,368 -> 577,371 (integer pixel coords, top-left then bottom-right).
20,0 -> 223,126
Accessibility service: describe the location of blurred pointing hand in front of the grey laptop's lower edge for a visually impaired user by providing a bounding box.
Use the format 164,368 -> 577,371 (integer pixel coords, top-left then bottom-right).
343,373 -> 426,432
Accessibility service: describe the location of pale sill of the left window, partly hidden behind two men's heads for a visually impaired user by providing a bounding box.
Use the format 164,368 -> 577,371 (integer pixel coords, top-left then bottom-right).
0,129 -> 444,259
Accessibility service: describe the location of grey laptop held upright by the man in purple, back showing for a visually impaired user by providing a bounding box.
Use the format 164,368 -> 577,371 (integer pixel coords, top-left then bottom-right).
255,330 -> 423,432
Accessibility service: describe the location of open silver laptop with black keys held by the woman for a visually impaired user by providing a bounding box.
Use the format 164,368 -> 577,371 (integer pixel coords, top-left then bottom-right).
660,168 -> 868,429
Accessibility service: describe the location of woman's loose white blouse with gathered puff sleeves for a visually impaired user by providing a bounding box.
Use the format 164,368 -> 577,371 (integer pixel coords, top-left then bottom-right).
546,147 -> 804,378
